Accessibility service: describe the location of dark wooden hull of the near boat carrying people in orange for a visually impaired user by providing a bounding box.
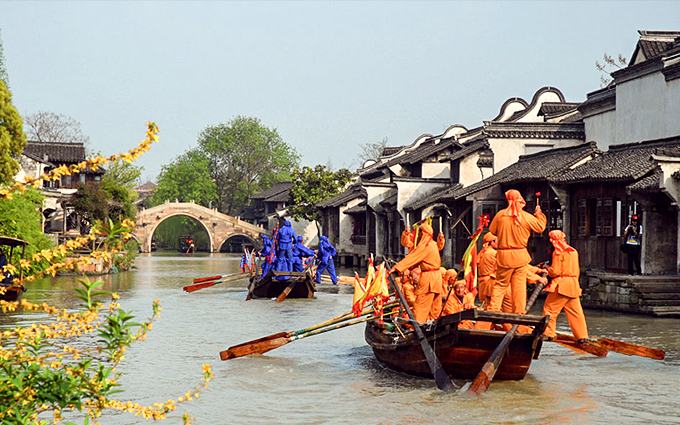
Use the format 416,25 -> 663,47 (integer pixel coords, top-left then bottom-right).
364,309 -> 548,380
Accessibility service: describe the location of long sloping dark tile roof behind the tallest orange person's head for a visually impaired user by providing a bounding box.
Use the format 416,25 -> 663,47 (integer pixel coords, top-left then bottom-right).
452,142 -> 601,199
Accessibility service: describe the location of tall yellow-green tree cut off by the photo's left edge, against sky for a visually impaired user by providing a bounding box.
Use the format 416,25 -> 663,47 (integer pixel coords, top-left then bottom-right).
0,79 -> 26,184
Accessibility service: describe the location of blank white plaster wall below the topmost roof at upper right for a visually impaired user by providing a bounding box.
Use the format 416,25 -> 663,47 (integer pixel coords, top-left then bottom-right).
616,72 -> 680,144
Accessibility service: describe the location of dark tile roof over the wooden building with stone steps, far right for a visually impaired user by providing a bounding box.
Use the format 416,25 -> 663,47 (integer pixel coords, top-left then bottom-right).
551,136 -> 680,183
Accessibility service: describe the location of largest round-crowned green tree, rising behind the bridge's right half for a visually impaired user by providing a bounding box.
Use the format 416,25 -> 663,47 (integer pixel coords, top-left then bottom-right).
198,116 -> 300,214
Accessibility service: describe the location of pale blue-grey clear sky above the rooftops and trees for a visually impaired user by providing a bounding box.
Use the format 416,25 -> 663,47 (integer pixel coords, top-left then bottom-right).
0,1 -> 680,182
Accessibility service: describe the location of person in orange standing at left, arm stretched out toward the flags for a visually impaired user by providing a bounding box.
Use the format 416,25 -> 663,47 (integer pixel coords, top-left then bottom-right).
390,223 -> 442,322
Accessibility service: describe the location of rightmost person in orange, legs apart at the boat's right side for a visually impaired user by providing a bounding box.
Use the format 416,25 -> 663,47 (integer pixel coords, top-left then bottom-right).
543,230 -> 588,344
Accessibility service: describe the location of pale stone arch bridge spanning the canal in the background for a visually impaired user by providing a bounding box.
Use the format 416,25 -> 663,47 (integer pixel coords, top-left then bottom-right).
132,201 -> 265,252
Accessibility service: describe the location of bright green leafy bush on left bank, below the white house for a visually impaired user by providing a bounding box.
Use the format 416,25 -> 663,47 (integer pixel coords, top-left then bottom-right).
0,188 -> 52,272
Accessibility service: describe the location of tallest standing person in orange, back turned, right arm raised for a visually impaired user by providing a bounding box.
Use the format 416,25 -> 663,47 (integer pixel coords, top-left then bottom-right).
487,189 -> 546,318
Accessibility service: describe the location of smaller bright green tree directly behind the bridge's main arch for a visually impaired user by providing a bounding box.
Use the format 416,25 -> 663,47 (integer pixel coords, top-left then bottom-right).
151,149 -> 217,207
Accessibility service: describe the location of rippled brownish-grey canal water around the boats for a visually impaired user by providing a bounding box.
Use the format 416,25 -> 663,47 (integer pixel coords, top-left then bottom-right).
5,253 -> 680,425
